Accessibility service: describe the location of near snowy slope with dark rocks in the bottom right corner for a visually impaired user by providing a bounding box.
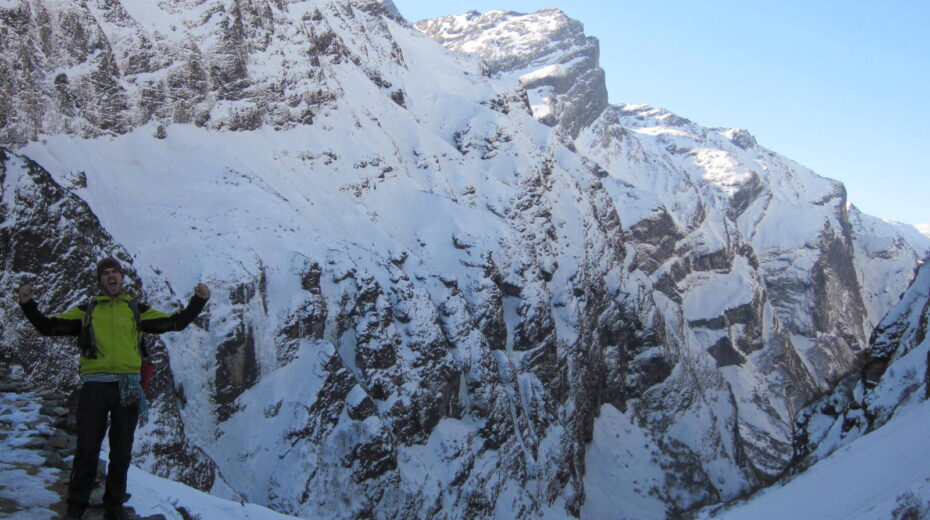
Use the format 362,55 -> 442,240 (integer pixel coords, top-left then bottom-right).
703,264 -> 930,520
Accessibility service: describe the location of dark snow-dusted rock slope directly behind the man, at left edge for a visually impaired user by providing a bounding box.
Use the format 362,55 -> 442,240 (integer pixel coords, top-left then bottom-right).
0,149 -> 121,386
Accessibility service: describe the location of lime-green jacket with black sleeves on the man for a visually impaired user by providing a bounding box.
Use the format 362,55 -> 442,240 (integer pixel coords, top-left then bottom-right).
21,293 -> 207,375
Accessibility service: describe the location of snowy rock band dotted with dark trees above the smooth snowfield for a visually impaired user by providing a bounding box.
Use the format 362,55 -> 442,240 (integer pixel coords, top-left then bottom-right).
0,0 -> 403,145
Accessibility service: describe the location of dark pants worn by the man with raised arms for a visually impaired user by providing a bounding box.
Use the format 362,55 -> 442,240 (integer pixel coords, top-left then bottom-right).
68,382 -> 139,510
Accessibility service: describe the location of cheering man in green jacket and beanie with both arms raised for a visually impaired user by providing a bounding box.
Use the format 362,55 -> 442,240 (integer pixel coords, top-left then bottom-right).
18,257 -> 210,519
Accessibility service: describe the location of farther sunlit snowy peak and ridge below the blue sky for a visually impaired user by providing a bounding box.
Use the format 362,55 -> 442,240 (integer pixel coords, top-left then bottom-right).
416,11 -> 927,516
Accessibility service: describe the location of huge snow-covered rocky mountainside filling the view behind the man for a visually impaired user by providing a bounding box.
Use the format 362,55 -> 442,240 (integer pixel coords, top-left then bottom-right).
0,0 -> 930,519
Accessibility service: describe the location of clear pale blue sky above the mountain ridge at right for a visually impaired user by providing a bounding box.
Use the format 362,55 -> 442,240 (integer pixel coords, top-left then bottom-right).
394,0 -> 930,228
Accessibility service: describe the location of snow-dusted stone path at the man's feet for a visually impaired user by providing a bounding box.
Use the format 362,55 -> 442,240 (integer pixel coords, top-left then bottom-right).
0,366 -> 164,520
